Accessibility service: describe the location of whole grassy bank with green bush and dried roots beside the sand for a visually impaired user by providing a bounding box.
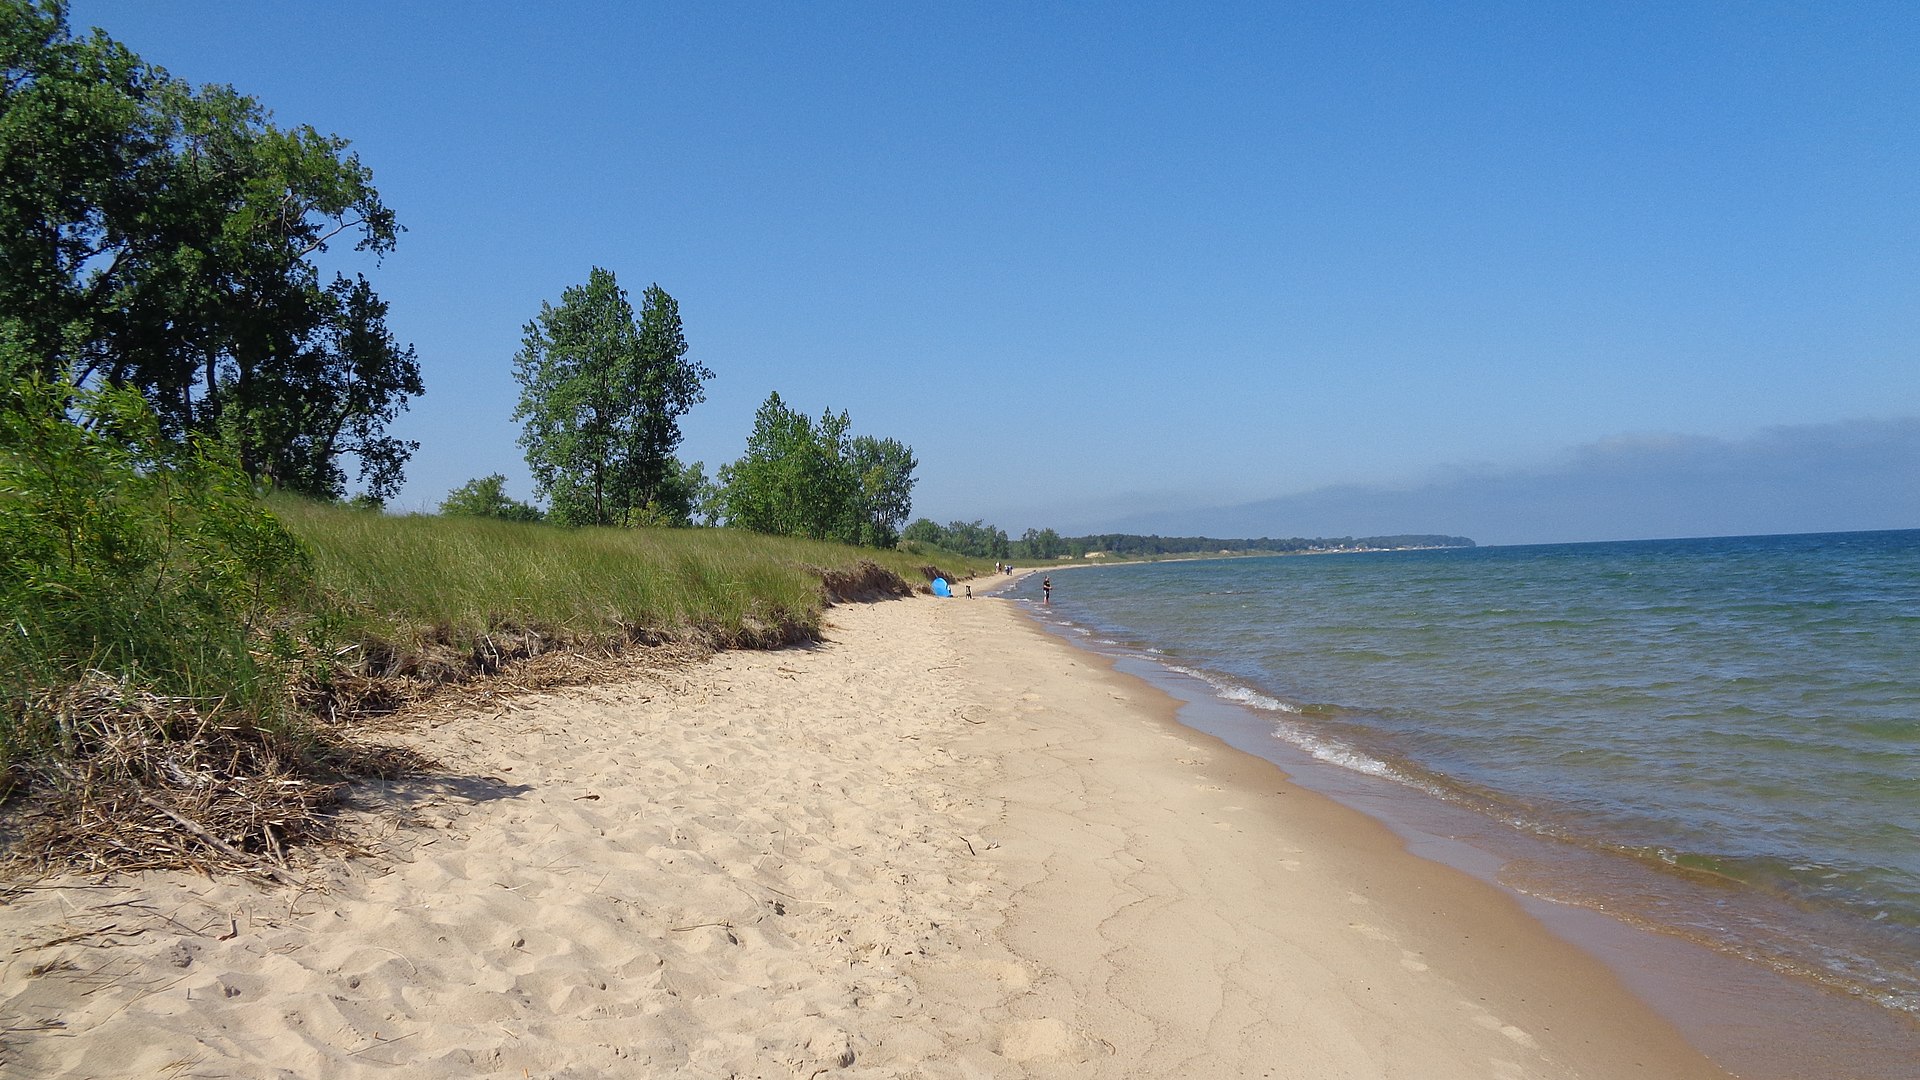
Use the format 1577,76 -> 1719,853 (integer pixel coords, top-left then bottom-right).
0,380 -> 981,868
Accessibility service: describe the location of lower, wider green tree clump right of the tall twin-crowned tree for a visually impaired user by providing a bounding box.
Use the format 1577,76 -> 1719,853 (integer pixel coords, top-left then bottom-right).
718,392 -> 918,548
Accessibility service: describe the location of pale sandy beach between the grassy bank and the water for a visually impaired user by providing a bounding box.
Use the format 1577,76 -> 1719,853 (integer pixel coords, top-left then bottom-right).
0,598 -> 1720,1080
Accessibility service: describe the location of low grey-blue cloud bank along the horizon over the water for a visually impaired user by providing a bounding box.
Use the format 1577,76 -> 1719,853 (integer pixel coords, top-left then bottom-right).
1102,417 -> 1920,544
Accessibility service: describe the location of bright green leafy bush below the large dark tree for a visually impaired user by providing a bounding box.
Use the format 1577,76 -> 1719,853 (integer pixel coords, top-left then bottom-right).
0,377 -> 311,757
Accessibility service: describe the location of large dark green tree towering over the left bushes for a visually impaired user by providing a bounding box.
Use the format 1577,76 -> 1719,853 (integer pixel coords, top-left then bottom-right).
0,0 -> 424,500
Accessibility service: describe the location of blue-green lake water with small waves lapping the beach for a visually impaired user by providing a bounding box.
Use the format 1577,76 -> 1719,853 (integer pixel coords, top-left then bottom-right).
1014,530 -> 1920,1013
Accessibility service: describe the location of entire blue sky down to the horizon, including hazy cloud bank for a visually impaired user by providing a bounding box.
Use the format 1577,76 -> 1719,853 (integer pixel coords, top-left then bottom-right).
73,0 -> 1920,542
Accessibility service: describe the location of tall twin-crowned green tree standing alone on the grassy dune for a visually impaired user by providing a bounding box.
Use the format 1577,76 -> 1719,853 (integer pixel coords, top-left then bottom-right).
513,267 -> 712,525
